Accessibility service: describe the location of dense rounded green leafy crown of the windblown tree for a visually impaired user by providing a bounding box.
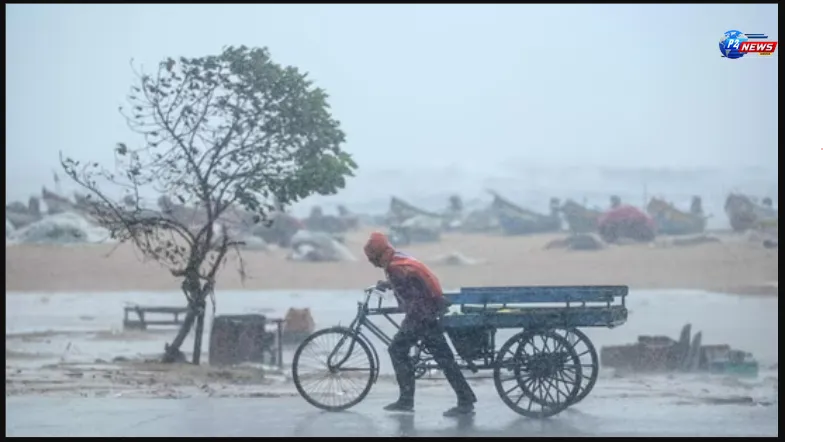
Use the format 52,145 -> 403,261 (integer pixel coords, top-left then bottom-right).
130,46 -> 357,215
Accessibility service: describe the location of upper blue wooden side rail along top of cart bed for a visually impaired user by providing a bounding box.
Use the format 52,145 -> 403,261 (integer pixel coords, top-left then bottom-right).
446,285 -> 629,304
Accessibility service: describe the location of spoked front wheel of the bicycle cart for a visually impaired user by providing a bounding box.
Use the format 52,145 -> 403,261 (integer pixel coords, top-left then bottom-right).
292,327 -> 377,411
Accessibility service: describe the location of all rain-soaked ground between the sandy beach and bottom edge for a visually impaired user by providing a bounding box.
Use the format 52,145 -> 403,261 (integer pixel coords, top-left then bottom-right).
6,291 -> 778,437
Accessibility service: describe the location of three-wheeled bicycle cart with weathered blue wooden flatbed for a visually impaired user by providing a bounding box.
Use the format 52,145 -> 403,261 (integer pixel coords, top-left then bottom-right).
292,286 -> 629,418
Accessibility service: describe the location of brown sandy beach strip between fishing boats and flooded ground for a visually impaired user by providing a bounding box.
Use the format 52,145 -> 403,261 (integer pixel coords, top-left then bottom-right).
6,230 -> 778,294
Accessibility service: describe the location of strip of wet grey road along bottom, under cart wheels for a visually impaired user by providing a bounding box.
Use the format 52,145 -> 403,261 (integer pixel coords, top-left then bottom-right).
6,384 -> 778,437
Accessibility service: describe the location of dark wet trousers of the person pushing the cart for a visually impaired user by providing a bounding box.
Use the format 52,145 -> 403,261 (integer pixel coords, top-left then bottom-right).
389,321 -> 477,405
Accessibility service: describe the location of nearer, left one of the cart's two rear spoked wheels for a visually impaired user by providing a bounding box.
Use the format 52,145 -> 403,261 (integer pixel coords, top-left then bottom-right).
494,330 -> 583,418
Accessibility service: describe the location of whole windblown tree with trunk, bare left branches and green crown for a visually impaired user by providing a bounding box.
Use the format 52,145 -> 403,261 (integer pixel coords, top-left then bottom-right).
61,46 -> 357,363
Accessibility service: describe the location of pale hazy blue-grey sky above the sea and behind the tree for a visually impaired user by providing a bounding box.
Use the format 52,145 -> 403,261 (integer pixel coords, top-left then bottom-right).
6,4 -> 779,197
